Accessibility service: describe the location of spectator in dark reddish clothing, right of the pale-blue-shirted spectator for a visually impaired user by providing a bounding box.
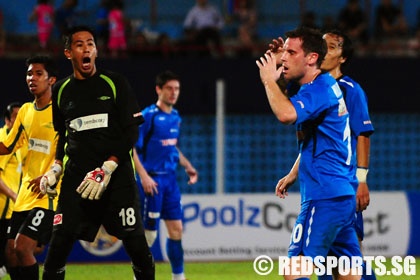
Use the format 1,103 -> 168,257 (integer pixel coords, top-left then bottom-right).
233,0 -> 258,56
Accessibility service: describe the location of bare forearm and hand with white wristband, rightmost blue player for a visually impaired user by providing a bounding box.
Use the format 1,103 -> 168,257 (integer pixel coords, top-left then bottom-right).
356,134 -> 370,211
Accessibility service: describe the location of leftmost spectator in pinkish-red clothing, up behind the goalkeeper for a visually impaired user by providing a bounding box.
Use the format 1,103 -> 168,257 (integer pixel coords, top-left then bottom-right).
29,0 -> 54,49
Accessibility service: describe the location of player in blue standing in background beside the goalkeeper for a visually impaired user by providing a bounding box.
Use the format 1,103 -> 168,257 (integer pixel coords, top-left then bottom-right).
134,71 -> 198,280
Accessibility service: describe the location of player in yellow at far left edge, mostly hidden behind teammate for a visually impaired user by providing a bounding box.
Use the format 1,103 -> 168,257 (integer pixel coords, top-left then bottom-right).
0,102 -> 27,279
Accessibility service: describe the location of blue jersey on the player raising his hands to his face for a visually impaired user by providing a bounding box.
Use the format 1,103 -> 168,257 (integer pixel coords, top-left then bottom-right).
290,73 -> 357,202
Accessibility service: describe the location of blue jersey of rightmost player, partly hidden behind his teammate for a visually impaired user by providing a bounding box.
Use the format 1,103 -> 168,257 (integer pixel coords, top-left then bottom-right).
337,76 -> 374,186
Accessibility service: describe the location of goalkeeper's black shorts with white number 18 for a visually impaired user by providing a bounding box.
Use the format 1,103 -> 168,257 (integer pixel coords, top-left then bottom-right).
54,162 -> 144,242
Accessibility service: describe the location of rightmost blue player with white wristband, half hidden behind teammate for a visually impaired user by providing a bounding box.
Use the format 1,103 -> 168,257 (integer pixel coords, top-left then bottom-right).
320,30 -> 376,280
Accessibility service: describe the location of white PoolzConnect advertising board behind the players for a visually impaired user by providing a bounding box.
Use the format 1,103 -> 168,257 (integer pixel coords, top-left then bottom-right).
152,192 -> 420,261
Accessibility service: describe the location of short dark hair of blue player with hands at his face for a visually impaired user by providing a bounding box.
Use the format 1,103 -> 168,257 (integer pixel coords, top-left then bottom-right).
285,27 -> 328,67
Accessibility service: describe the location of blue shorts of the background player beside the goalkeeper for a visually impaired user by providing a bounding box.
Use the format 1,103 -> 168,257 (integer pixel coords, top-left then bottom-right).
139,172 -> 182,230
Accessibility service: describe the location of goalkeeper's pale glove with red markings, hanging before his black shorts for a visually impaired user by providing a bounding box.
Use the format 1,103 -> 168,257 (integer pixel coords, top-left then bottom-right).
76,160 -> 118,200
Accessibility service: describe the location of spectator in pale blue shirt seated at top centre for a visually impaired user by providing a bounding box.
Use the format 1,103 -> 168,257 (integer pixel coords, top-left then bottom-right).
184,0 -> 224,54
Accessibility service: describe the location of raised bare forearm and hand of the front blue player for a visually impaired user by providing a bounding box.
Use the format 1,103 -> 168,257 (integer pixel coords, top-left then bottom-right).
256,53 -> 297,124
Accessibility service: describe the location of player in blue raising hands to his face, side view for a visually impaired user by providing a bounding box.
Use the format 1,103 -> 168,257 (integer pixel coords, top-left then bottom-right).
256,28 -> 361,280
